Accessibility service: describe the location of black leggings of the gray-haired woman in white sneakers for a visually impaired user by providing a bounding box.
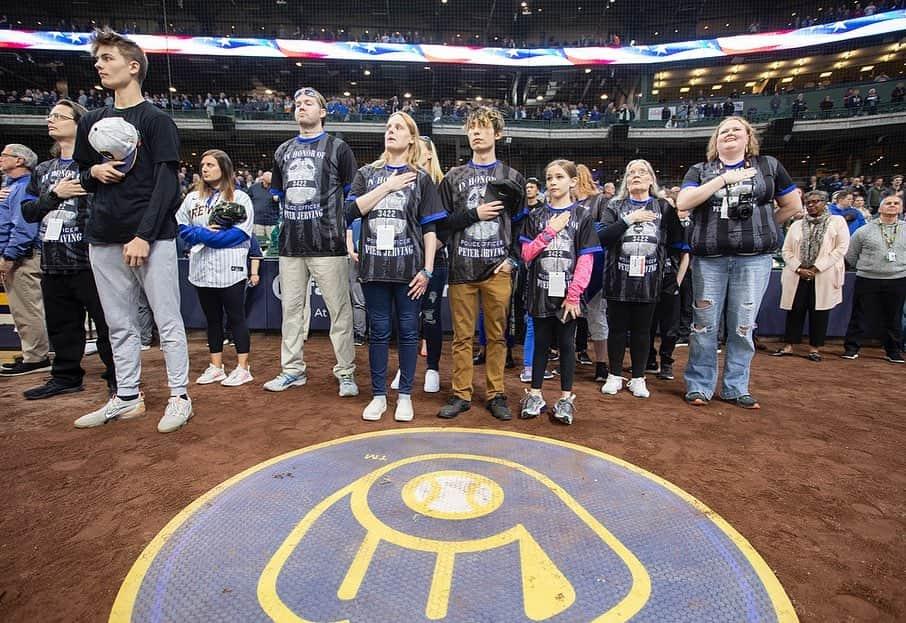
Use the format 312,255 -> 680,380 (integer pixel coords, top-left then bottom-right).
607,300 -> 657,379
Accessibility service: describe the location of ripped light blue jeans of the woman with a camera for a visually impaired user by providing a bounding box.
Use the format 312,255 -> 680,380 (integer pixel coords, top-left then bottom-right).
685,255 -> 771,400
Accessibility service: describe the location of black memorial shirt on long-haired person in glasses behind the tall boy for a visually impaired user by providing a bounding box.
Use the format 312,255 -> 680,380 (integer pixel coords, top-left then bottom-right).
26,158 -> 91,274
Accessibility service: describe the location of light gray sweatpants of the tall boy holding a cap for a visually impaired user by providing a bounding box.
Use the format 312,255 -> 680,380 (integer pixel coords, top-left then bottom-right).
89,240 -> 189,396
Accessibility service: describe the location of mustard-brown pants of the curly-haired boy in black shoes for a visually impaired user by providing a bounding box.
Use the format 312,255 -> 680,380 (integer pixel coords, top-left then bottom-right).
449,271 -> 513,401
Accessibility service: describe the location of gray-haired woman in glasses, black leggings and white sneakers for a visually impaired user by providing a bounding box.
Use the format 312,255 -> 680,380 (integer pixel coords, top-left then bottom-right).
598,160 -> 683,398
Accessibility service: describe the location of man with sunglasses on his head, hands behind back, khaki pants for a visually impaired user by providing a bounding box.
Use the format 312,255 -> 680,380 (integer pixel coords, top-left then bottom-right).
264,87 -> 359,396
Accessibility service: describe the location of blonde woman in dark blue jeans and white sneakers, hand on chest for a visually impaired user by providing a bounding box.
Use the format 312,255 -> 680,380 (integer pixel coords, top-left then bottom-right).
346,112 -> 447,422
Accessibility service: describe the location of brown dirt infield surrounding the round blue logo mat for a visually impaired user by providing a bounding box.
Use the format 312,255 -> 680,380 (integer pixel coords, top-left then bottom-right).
0,335 -> 906,623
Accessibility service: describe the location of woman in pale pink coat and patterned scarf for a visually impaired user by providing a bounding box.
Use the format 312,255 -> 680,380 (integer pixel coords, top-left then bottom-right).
774,190 -> 849,361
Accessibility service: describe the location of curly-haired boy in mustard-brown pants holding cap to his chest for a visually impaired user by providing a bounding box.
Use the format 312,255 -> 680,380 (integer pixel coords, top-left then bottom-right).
437,108 -> 525,420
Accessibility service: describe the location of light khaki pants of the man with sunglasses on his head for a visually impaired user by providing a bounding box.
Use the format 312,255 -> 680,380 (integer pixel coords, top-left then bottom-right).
280,255 -> 355,377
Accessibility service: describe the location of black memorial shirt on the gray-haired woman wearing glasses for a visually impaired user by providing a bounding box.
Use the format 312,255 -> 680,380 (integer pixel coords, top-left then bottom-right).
601,198 -> 683,303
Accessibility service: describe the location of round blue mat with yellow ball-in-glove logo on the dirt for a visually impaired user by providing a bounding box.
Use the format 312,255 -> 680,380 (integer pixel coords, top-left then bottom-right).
110,428 -> 797,623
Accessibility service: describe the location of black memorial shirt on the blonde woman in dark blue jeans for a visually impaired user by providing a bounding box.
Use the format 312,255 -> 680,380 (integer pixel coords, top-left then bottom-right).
347,164 -> 447,283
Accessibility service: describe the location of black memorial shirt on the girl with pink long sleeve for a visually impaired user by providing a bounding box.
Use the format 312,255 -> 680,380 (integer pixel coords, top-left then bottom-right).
519,202 -> 601,318
